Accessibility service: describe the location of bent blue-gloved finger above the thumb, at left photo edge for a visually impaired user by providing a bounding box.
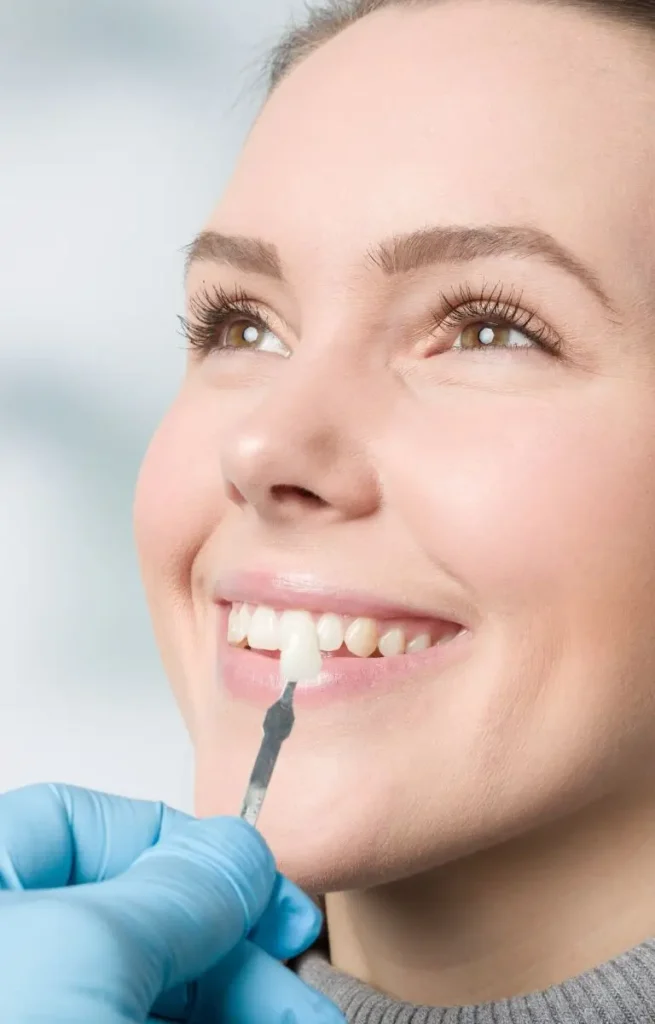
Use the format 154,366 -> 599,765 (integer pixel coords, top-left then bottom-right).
0,783 -> 190,891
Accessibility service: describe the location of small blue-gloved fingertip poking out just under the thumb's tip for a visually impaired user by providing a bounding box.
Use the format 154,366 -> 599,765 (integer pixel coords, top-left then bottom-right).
249,874 -> 322,961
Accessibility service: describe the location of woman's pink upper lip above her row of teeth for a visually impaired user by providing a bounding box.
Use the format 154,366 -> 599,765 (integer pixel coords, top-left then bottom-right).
214,571 -> 464,625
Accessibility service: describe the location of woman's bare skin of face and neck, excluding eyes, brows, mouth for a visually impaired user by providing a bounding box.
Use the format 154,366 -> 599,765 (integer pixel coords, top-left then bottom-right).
136,0 -> 655,1005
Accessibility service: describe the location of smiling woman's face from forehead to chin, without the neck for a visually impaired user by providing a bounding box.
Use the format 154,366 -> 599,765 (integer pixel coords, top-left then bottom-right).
136,0 -> 655,891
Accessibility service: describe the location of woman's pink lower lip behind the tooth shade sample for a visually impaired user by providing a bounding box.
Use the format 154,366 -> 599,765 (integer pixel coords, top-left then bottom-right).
218,606 -> 469,708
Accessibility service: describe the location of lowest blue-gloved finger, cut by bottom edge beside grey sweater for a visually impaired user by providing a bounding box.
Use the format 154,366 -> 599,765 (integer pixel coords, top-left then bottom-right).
188,940 -> 345,1024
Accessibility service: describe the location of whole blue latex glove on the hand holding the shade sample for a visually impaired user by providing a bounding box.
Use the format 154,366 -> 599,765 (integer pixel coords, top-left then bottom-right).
0,785 -> 343,1024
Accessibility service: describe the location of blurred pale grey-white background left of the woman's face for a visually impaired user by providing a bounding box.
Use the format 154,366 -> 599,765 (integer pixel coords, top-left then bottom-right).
0,0 -> 304,809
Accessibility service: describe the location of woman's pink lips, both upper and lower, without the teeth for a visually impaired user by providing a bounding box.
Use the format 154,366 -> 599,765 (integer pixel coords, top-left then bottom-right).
215,573 -> 470,709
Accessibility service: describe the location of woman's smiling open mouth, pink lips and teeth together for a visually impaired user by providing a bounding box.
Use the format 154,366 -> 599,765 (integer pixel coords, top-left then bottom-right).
214,572 -> 471,708
